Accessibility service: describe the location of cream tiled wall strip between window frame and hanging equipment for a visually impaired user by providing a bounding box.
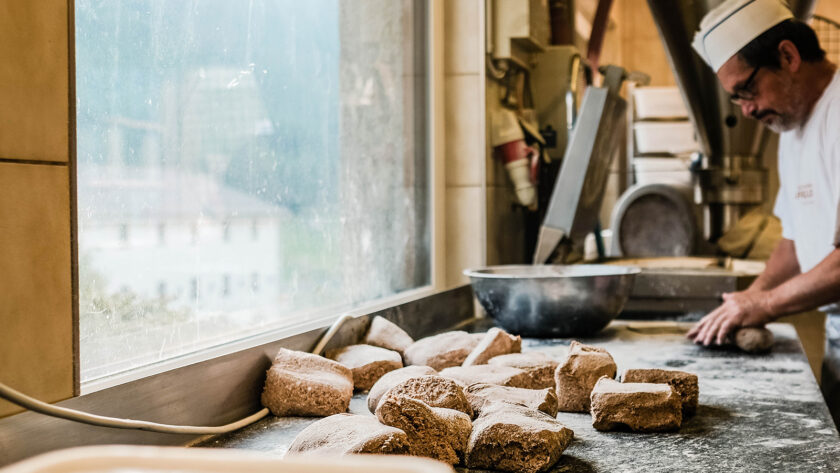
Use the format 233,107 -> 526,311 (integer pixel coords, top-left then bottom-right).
444,0 -> 524,274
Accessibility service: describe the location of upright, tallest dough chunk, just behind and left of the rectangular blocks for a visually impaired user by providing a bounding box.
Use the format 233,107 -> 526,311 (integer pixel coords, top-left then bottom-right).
554,340 -> 616,412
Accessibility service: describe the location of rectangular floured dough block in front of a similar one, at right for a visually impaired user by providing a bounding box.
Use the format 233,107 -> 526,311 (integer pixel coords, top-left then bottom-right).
592,376 -> 682,432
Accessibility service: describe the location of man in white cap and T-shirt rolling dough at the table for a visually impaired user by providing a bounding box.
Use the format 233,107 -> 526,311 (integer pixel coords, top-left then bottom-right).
688,0 -> 840,424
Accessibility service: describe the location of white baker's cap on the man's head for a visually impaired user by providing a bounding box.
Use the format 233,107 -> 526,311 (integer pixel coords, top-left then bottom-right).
692,0 -> 793,72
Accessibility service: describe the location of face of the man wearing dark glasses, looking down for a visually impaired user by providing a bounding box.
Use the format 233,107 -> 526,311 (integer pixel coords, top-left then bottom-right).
717,54 -> 804,133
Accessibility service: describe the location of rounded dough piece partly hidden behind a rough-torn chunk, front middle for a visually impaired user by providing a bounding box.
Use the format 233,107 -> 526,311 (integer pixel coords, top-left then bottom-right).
377,375 -> 473,417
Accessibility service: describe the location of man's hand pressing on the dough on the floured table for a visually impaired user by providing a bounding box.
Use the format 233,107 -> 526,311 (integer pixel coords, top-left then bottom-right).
686,290 -> 772,346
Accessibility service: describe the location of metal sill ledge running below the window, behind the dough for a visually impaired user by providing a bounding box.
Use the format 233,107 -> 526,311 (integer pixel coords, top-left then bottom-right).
0,286 -> 474,466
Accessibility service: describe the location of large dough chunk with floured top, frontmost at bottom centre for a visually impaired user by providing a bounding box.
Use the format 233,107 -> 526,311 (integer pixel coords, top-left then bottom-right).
464,402 -> 574,473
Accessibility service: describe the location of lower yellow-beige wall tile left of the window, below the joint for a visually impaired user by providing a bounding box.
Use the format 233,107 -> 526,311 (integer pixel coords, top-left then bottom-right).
0,163 -> 74,416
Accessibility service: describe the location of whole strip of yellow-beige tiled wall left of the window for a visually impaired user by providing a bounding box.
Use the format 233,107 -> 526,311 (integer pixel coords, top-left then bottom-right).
0,0 -> 75,416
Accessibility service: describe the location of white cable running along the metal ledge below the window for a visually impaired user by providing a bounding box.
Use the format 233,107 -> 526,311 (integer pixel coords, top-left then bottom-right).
0,314 -> 351,435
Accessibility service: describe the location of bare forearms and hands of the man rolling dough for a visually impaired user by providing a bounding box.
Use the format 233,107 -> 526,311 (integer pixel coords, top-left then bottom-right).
688,240 -> 840,345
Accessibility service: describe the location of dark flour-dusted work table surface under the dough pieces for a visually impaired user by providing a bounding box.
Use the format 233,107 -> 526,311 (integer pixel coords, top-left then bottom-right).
198,319 -> 840,472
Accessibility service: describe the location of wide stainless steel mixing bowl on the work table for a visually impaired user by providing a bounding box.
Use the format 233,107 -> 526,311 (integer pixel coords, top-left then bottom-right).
464,264 -> 641,337
